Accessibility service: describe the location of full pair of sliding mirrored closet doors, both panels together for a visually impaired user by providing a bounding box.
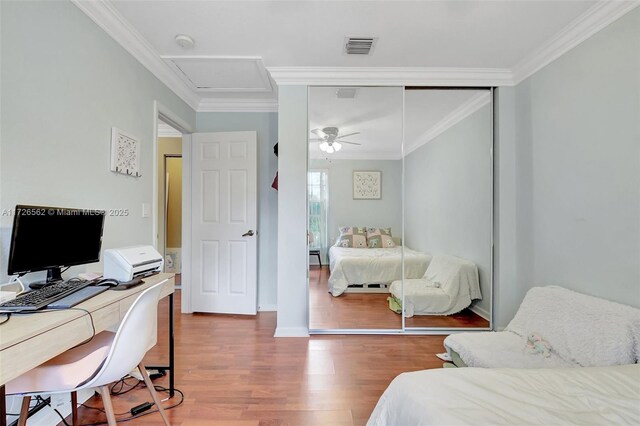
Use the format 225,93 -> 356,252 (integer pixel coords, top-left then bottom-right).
306,87 -> 493,332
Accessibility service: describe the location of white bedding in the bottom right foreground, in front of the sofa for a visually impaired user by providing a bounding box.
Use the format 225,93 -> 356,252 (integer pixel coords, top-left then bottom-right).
367,364 -> 640,426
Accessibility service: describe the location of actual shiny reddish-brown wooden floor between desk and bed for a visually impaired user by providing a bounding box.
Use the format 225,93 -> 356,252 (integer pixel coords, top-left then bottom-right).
60,293 -> 444,426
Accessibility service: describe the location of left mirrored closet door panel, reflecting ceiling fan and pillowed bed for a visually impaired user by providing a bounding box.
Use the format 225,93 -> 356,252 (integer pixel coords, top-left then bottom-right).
307,87 -> 404,332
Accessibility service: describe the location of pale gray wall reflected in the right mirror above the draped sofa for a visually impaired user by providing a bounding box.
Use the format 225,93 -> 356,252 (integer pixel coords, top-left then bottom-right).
404,105 -> 492,315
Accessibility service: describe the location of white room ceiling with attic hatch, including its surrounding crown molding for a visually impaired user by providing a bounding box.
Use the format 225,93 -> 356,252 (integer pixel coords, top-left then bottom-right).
72,0 -> 637,111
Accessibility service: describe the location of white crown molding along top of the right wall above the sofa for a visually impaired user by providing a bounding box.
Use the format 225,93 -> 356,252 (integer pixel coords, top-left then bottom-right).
512,0 -> 640,85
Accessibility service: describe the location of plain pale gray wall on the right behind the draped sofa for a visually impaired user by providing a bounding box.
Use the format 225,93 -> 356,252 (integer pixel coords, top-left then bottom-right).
497,9 -> 640,325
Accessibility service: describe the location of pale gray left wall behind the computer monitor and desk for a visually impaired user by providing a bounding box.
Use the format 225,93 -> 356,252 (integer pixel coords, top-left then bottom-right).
0,2 -> 195,281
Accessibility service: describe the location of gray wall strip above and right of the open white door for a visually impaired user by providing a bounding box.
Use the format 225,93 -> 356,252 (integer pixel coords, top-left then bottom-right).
196,112 -> 278,310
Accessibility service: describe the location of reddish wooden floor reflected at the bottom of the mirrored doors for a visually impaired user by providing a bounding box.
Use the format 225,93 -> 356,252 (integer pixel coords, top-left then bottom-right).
309,266 -> 489,329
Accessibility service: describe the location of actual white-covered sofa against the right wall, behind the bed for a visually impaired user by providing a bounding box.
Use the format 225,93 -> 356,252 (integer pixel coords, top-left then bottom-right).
444,286 -> 640,368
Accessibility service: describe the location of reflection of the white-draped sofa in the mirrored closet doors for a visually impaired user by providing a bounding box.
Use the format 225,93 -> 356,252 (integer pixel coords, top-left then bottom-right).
389,255 -> 482,317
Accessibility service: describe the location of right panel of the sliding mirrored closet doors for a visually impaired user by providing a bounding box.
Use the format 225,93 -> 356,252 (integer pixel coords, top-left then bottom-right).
403,88 -> 493,330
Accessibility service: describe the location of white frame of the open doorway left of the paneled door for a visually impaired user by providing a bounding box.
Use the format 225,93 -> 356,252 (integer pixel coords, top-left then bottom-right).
151,100 -> 195,313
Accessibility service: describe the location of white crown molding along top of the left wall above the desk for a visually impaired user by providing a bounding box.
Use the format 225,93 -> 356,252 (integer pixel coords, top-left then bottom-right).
71,0 -> 200,110
